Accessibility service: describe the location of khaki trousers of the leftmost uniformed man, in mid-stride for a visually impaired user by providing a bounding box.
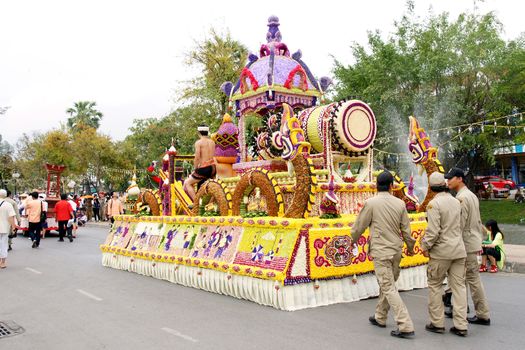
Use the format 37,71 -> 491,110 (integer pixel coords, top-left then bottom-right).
374,253 -> 414,332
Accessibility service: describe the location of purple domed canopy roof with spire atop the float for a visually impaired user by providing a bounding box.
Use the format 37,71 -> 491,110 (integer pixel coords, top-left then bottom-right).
221,16 -> 332,116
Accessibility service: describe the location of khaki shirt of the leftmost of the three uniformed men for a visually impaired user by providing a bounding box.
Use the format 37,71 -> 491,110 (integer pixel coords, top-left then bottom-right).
352,192 -> 416,259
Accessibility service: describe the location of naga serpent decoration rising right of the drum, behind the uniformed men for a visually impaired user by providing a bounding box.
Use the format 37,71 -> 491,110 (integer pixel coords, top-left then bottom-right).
408,117 -> 445,212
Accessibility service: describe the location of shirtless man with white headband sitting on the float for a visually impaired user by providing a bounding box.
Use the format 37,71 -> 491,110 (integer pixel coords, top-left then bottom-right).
184,125 -> 216,200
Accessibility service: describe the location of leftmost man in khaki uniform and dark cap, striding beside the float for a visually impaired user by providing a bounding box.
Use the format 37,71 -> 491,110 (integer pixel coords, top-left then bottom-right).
352,171 -> 416,338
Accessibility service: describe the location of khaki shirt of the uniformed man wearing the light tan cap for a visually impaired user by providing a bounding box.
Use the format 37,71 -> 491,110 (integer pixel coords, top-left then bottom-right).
421,192 -> 467,260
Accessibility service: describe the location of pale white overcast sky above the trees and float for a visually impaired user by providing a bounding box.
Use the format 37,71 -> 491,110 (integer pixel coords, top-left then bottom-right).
0,0 -> 525,143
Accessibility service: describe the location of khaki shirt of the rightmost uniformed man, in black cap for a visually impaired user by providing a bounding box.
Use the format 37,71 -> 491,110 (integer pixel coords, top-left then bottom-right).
456,186 -> 486,253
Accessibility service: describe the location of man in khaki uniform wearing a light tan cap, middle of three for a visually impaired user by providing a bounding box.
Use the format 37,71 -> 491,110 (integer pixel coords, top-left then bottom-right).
421,172 -> 468,336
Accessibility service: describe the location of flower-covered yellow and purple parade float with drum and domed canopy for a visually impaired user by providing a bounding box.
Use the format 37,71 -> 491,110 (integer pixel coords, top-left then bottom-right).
101,17 -> 443,310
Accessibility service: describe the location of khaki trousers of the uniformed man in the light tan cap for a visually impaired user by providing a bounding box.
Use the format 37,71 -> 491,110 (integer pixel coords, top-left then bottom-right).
427,258 -> 468,330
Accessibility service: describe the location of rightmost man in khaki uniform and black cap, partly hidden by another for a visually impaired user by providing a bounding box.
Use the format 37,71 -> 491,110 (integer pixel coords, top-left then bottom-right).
445,168 -> 490,326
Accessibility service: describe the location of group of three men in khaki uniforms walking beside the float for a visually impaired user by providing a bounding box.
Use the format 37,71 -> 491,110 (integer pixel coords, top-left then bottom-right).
352,168 -> 490,338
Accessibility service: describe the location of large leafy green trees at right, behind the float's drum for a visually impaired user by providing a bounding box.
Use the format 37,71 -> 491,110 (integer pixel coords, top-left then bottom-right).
334,7 -> 525,173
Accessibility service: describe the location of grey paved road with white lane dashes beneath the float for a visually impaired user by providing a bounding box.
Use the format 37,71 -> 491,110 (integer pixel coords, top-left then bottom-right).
0,225 -> 525,350
